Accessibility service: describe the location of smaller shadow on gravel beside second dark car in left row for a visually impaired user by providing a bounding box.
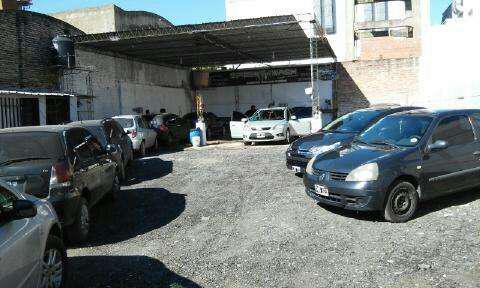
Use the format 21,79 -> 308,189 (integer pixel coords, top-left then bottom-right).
125,157 -> 173,186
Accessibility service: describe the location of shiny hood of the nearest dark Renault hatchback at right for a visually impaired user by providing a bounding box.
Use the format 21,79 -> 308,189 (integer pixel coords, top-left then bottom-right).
313,144 -> 394,173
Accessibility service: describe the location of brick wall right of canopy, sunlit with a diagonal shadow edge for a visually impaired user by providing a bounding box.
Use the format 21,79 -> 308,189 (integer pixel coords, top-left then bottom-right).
334,58 -> 419,115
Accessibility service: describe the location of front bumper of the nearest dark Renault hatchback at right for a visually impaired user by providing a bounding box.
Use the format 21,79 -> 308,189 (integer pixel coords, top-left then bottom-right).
303,173 -> 385,211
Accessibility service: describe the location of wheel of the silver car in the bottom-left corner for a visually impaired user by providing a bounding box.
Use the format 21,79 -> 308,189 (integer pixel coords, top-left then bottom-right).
40,235 -> 68,288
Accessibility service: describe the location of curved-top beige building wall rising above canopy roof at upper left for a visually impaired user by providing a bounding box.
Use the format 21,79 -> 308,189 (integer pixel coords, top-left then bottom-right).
52,4 -> 172,34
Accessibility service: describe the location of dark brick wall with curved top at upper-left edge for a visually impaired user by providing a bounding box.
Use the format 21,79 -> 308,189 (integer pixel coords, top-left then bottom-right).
0,11 -> 81,88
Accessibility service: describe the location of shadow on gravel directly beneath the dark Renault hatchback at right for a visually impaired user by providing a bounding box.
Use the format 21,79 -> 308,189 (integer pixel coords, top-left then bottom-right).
318,189 -> 480,222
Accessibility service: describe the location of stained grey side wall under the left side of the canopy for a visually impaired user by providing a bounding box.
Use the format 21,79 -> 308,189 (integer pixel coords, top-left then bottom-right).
63,49 -> 192,118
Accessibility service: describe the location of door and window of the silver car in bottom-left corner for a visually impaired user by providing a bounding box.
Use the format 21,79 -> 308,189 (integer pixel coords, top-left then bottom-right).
0,186 -> 43,288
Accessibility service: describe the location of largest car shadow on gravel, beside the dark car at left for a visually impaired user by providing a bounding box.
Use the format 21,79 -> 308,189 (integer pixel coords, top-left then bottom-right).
81,188 -> 186,247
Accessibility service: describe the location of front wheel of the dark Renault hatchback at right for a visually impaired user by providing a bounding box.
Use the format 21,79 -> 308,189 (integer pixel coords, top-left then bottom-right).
384,182 -> 419,223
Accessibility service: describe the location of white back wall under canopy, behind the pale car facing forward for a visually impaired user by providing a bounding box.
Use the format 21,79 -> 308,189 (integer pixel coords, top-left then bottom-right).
200,81 -> 333,117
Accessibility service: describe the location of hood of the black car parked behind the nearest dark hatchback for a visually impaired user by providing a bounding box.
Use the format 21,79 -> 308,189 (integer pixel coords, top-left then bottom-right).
293,132 -> 355,151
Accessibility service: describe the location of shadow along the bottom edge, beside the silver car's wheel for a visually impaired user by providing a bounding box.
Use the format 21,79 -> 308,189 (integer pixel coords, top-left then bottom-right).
68,256 -> 200,288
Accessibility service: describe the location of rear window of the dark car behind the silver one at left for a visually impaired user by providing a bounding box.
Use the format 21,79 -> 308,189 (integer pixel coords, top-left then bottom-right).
0,132 -> 63,163
